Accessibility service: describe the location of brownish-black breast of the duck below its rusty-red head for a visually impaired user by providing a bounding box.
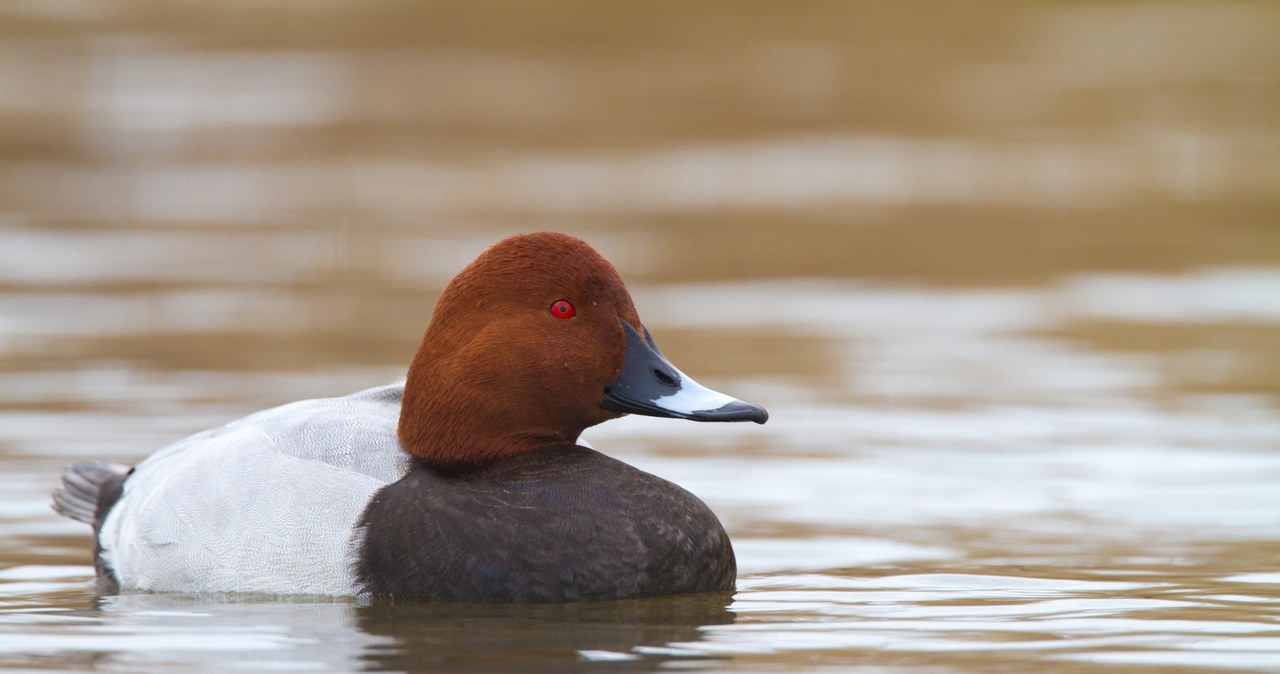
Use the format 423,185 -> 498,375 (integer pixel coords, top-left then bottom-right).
356,445 -> 737,601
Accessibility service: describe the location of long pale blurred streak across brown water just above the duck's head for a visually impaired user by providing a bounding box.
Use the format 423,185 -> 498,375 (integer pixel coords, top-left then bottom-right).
6,136 -> 1280,224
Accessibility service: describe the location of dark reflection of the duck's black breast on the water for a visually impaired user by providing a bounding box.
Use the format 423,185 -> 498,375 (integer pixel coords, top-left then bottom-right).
357,592 -> 733,671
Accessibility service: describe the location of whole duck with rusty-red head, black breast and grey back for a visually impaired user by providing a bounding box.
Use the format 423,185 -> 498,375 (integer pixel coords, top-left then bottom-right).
52,231 -> 768,602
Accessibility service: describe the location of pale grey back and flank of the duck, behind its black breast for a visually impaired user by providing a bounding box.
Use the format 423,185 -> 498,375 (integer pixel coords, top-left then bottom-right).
97,385 -> 412,595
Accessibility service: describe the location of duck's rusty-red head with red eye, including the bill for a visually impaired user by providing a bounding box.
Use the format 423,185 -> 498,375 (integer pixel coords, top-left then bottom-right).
399,231 -> 768,468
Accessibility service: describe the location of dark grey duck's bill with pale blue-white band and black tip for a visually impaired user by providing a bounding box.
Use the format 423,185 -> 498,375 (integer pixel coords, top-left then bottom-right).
600,318 -> 769,423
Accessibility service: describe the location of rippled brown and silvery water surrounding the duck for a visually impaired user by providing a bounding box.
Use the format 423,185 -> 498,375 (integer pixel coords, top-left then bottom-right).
0,0 -> 1280,673
